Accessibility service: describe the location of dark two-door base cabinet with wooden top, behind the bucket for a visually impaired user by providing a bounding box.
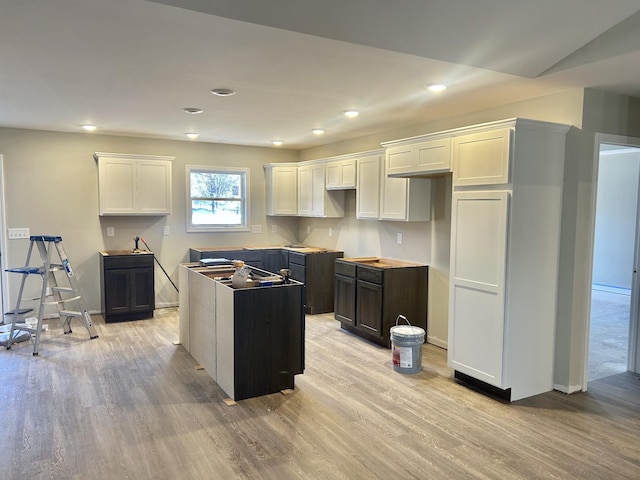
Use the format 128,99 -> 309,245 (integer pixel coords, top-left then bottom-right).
334,257 -> 429,348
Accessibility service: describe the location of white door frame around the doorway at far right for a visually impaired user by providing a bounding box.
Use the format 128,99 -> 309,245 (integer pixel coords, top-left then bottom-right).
582,133 -> 640,391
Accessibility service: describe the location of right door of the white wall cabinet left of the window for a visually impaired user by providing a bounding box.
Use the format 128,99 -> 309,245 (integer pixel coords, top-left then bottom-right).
136,160 -> 171,215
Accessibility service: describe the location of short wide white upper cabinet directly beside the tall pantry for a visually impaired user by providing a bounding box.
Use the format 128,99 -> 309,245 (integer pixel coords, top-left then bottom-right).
383,136 -> 451,177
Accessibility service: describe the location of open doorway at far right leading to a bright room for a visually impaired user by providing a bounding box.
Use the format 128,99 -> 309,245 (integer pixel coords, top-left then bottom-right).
586,135 -> 640,382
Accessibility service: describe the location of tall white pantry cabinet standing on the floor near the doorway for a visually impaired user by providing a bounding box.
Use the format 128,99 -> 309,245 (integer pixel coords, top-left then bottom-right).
448,119 -> 569,401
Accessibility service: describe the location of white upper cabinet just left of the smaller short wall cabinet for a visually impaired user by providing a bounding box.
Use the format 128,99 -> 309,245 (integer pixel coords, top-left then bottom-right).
298,161 -> 344,217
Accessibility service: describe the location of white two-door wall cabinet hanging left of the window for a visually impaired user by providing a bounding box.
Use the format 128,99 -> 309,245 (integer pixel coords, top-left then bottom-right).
94,152 -> 175,216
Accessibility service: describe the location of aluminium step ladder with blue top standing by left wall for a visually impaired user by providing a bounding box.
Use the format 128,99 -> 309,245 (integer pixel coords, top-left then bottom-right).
6,235 -> 98,355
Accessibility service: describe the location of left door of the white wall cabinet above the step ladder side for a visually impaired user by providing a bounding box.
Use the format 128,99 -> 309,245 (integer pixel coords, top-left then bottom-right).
98,157 -> 137,215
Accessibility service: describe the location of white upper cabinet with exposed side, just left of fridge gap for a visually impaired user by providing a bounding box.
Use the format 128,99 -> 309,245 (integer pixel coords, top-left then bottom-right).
378,156 -> 431,222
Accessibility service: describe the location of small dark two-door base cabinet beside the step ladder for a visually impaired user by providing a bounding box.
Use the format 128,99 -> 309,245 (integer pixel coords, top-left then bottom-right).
100,250 -> 155,322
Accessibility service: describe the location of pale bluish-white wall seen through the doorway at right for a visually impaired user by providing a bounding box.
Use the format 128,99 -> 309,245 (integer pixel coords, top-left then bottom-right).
593,148 -> 640,289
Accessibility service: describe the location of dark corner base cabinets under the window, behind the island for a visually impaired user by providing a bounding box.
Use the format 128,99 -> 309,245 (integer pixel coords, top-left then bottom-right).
189,245 -> 344,315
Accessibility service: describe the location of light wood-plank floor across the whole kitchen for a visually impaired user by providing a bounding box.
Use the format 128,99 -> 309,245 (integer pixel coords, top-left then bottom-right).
0,309 -> 640,480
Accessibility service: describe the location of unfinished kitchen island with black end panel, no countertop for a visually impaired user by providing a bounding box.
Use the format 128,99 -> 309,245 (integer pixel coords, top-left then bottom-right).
179,263 -> 304,400
